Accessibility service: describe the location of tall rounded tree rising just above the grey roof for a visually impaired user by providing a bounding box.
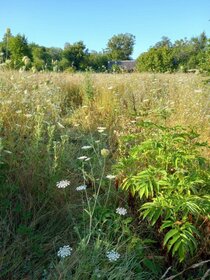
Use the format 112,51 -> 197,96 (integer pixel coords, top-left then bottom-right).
107,33 -> 135,60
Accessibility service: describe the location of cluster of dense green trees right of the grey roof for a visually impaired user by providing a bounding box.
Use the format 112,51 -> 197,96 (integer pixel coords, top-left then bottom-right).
137,32 -> 208,72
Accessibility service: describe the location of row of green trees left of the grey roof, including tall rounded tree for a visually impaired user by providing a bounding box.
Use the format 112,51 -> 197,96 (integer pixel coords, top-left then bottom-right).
0,28 -> 135,72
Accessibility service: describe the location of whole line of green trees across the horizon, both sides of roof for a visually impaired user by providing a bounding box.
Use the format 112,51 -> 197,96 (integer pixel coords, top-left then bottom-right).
0,28 -> 210,72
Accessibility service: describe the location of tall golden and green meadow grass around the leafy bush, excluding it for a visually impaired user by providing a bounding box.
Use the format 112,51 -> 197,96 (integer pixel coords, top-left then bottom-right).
0,71 -> 210,280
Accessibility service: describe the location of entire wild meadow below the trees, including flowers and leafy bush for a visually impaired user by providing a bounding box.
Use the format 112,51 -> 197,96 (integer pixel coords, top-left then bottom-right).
0,71 -> 210,280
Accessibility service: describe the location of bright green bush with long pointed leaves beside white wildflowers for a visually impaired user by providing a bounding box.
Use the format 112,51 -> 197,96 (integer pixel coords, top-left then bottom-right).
117,122 -> 210,262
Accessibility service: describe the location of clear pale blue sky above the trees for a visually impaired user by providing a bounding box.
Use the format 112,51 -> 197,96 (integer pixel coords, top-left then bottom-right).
0,0 -> 210,58
